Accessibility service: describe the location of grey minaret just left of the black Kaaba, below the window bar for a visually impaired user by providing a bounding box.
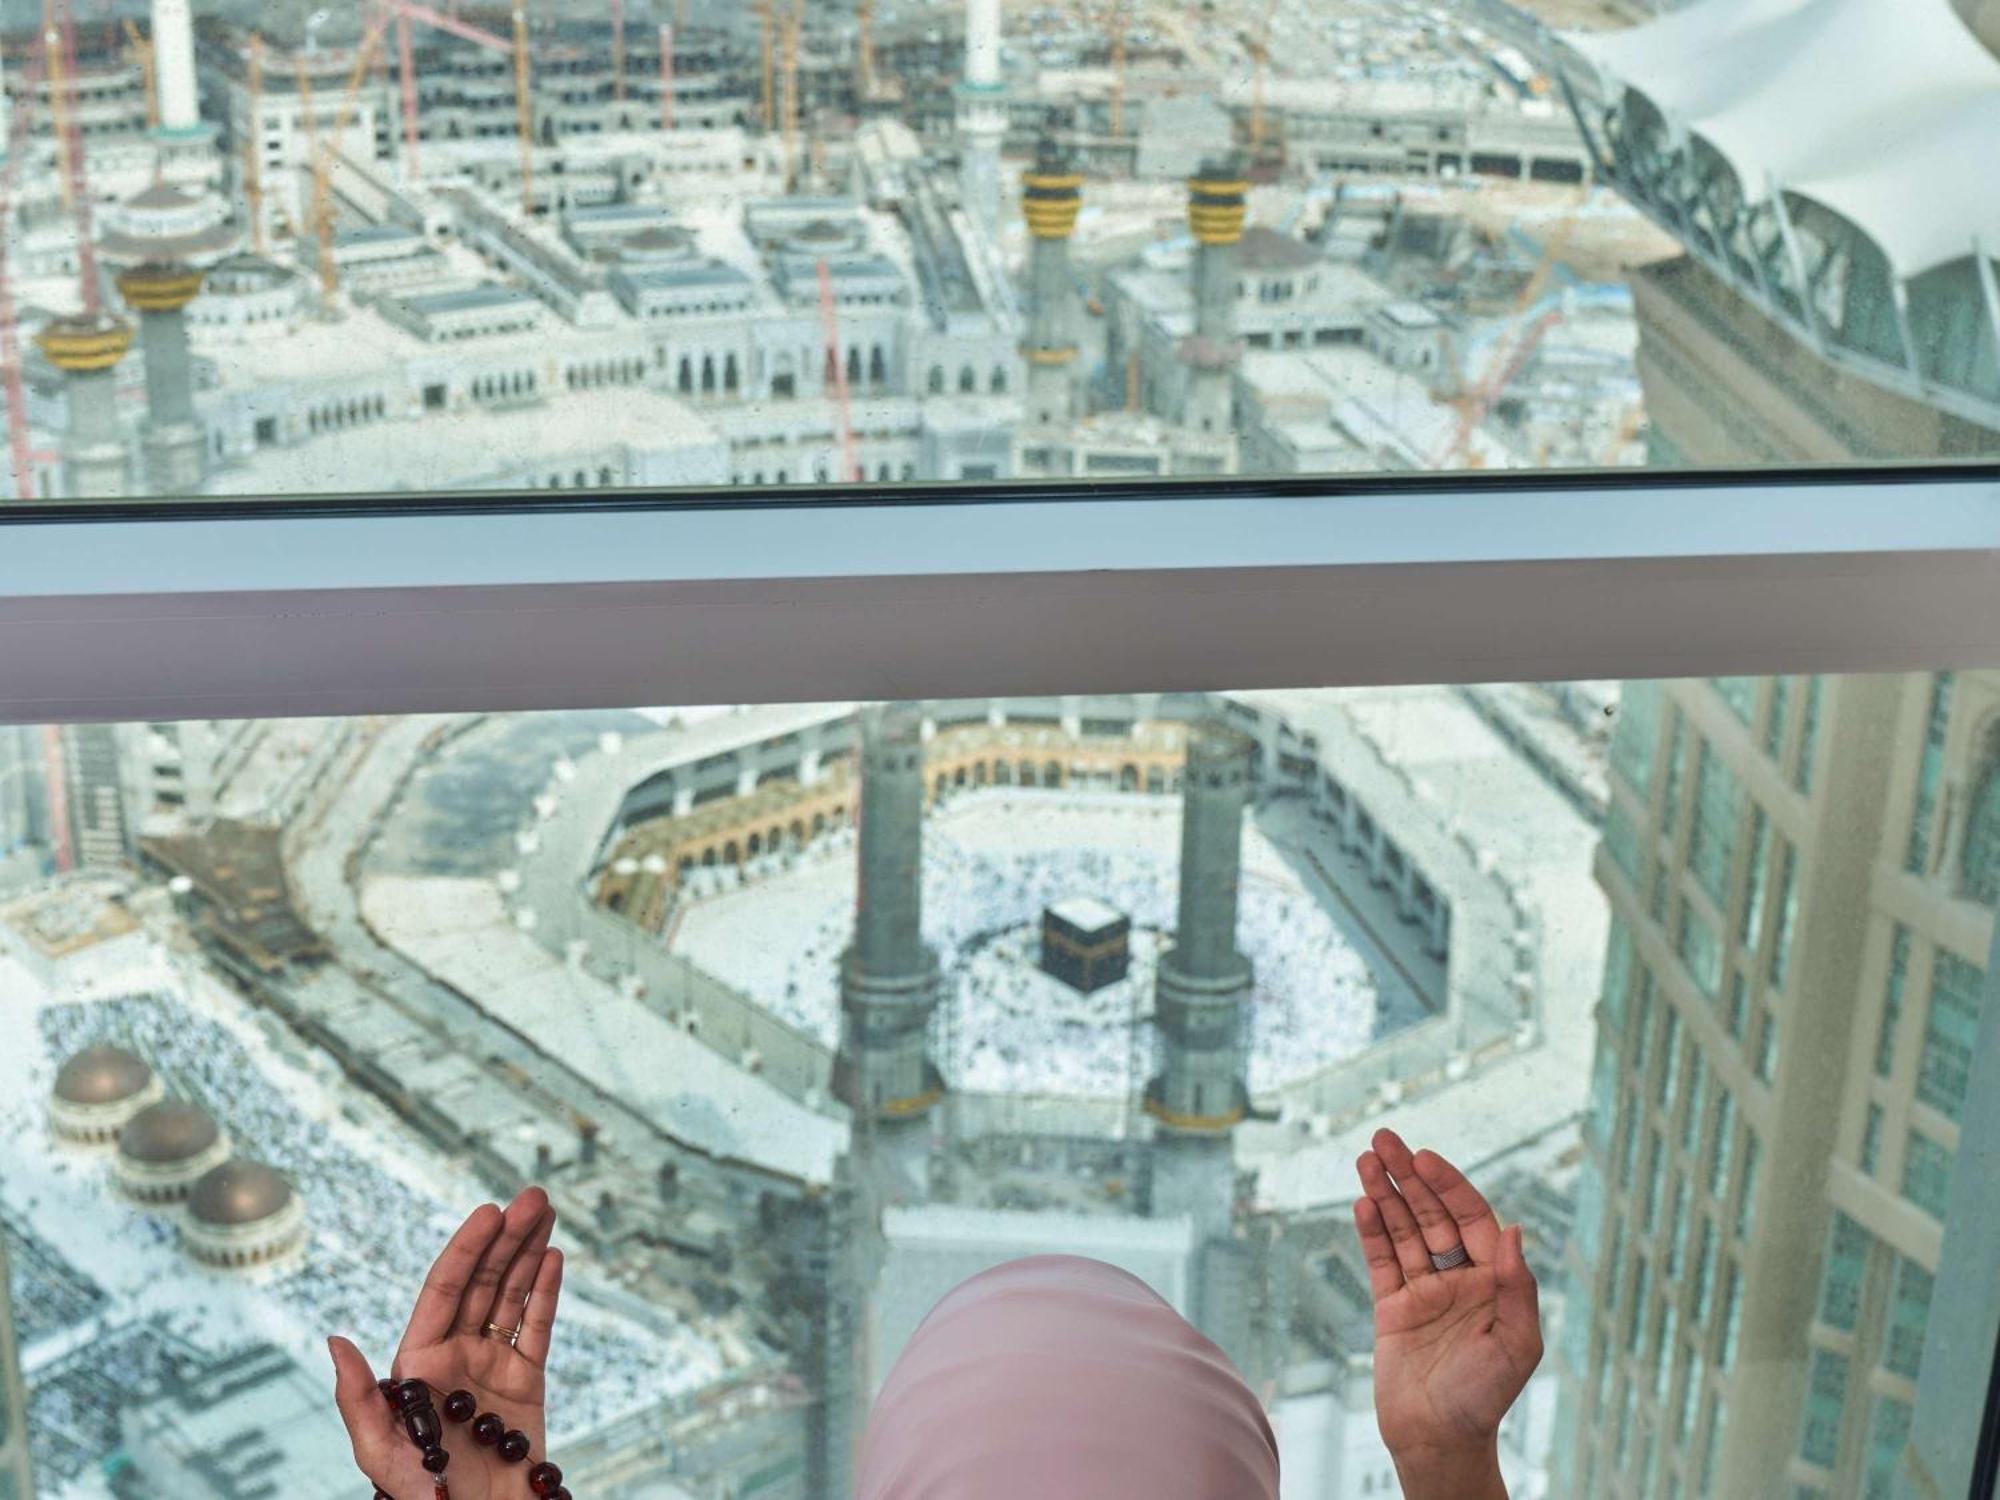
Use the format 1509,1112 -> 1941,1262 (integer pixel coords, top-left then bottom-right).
834,704 -> 944,1136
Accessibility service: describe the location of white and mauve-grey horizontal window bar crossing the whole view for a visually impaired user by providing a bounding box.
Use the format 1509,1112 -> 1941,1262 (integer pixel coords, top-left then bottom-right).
0,466 -> 2000,722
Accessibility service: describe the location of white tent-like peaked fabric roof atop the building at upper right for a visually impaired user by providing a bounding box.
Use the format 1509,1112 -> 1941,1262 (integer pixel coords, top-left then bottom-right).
1564,0 -> 2000,276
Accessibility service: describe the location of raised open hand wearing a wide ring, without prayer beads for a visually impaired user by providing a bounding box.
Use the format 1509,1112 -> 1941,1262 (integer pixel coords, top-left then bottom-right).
1354,1130 -> 1542,1500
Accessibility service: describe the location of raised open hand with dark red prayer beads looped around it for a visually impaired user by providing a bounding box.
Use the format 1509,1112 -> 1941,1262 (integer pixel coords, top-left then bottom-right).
326,1188 -> 562,1500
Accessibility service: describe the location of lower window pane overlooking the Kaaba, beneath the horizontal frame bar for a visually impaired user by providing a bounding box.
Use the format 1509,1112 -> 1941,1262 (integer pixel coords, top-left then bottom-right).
11,680 -> 2000,1500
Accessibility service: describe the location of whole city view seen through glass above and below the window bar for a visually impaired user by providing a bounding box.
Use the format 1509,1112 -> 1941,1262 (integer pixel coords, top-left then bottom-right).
0,0 -> 2000,1500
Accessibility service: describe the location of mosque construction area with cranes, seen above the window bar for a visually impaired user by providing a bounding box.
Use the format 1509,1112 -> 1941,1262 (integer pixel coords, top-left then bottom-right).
0,0 -> 1672,500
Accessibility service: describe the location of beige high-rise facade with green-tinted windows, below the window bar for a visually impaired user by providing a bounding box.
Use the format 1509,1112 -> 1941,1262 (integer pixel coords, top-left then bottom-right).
1556,674 -> 2000,1500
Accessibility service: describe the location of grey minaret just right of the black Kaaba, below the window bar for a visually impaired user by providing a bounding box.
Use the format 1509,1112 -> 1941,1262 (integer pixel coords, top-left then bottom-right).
1146,722 -> 1252,1236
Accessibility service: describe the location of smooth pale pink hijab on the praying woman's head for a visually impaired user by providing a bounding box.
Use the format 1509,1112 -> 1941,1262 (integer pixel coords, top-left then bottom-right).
854,1256 -> 1278,1500
